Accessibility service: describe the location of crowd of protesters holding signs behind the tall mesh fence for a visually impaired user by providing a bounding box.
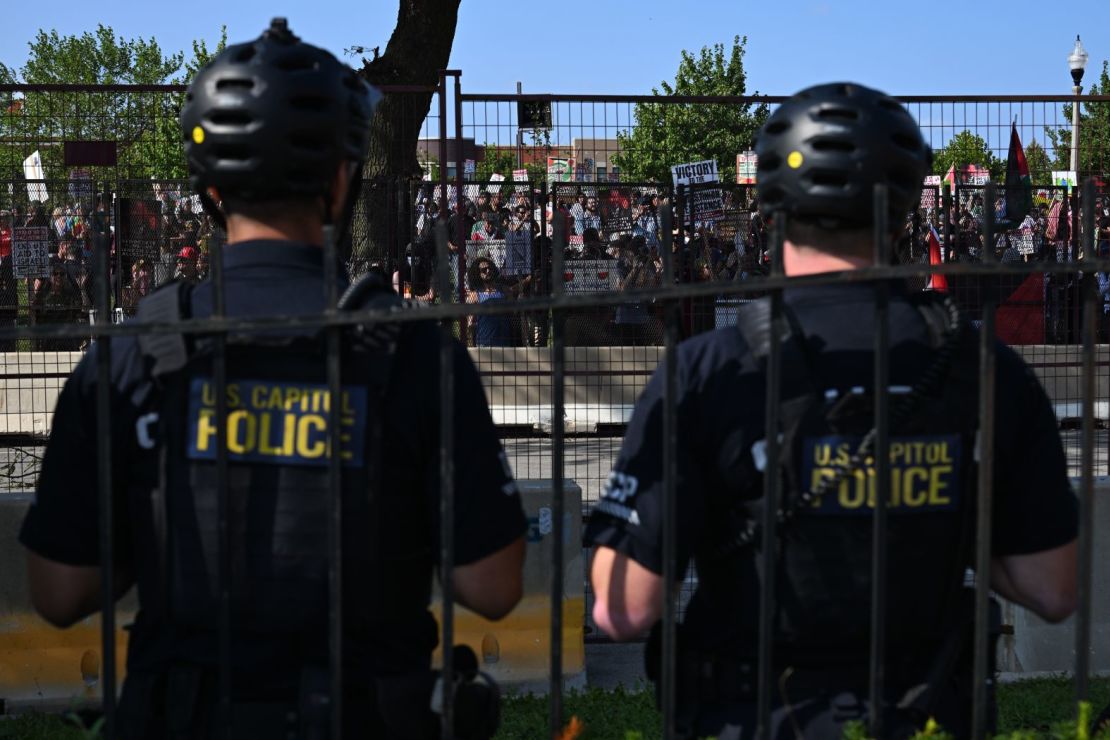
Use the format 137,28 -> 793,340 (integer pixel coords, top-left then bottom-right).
0,183 -> 1110,351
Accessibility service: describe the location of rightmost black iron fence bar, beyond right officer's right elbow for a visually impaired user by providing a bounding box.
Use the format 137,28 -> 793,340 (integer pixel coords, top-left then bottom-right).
1076,180 -> 1099,707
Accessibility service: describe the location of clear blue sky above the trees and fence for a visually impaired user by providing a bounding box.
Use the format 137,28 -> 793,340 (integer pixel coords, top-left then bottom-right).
0,0 -> 1110,94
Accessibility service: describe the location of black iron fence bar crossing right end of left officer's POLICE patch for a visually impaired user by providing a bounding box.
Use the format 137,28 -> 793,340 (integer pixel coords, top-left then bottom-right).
324,219 -> 343,740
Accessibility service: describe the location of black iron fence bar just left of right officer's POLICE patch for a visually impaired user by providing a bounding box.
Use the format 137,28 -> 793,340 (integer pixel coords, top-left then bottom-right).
756,211 -> 786,738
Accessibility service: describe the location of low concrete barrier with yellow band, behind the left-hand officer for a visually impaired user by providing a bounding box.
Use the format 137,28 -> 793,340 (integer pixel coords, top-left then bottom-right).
0,480 -> 586,713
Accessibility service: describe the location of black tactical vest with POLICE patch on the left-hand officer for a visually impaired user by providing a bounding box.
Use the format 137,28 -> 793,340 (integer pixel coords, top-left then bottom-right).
132,280 -> 433,642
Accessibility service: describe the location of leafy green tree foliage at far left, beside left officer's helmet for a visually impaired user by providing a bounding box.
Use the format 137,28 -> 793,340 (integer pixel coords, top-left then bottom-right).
0,24 -> 226,180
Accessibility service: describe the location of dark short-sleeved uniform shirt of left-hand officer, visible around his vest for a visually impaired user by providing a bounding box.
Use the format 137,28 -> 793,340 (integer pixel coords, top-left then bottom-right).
20,242 -> 526,678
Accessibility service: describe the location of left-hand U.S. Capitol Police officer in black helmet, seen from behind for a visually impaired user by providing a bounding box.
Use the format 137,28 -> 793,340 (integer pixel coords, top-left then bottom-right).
21,19 -> 525,739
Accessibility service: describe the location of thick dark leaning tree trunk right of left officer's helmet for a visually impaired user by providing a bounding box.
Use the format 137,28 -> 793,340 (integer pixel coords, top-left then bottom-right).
353,0 -> 460,271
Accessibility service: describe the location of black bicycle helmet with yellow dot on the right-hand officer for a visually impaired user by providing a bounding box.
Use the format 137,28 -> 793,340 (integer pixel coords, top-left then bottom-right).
756,82 -> 932,229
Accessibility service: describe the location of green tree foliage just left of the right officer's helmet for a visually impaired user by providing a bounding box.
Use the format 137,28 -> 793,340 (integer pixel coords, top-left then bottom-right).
613,37 -> 768,188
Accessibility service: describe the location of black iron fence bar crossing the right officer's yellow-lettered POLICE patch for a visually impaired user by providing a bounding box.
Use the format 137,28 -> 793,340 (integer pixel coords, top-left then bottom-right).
869,184 -> 890,738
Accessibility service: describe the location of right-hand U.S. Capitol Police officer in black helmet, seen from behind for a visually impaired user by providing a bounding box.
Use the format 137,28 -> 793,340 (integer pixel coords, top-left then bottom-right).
586,84 -> 1077,738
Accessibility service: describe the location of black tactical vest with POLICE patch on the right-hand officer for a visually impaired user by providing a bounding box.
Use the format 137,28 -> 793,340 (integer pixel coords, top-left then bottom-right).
698,296 -> 978,665
